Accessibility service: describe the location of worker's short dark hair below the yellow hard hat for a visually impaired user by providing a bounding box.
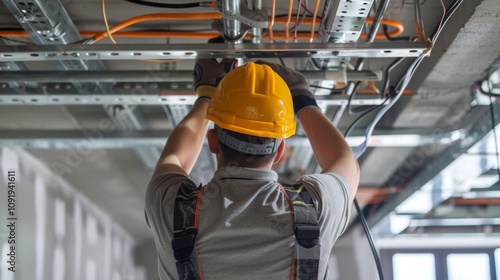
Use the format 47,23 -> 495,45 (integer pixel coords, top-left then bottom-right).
219,129 -> 278,168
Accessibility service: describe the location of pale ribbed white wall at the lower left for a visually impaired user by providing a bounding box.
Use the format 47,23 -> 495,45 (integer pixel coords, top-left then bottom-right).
0,148 -> 145,280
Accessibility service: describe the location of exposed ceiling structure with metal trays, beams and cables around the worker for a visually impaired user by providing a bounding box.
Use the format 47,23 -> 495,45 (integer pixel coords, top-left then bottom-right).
0,0 -> 500,243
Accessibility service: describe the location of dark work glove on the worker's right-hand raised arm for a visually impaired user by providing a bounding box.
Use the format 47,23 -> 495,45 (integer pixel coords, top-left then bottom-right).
255,60 -> 318,116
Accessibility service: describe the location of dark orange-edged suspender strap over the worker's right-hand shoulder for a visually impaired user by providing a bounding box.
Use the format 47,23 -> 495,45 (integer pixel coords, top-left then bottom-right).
280,184 -> 320,280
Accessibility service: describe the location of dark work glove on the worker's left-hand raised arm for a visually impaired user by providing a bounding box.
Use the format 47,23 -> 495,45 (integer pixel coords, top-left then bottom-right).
193,37 -> 237,100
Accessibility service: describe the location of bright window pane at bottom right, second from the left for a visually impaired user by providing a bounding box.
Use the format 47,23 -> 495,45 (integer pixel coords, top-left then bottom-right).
446,254 -> 491,280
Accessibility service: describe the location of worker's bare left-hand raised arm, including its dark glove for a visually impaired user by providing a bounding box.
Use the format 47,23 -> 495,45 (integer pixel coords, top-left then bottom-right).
153,59 -> 234,176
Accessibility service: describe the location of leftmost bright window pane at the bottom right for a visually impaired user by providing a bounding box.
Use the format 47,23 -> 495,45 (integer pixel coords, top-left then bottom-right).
392,254 -> 436,280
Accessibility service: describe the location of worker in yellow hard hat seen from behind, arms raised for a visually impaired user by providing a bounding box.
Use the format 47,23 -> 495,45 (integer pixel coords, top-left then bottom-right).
145,59 -> 359,280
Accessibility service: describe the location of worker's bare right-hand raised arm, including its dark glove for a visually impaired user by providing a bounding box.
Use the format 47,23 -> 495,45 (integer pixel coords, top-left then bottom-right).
257,61 -> 359,197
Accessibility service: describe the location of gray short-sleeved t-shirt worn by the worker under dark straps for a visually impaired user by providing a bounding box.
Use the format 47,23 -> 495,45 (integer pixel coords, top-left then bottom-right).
145,167 -> 350,280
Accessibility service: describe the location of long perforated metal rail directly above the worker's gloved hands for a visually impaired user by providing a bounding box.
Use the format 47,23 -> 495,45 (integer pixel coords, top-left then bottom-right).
0,42 -> 429,61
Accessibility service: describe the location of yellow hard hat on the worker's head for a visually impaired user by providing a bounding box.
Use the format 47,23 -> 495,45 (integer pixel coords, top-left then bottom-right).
206,62 -> 296,138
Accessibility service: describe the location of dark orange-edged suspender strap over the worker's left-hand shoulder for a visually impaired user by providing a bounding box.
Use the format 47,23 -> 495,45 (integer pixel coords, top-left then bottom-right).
172,183 -> 203,280
